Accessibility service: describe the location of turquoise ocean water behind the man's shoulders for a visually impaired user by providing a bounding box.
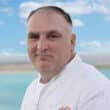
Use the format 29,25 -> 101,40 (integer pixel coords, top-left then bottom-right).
0,69 -> 110,110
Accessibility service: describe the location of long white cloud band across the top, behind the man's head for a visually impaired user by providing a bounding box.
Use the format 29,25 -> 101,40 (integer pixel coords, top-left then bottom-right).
20,0 -> 110,18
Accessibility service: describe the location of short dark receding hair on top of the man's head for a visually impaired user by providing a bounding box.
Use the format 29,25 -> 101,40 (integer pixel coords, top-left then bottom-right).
27,6 -> 72,26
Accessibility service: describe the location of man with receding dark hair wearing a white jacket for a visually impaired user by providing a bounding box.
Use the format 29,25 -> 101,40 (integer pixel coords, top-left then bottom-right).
21,6 -> 110,110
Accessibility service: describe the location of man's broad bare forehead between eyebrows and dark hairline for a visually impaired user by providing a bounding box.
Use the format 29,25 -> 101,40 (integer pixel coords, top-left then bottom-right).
27,10 -> 71,31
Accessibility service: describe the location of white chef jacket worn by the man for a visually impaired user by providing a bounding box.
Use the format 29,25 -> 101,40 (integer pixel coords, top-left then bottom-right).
20,55 -> 110,110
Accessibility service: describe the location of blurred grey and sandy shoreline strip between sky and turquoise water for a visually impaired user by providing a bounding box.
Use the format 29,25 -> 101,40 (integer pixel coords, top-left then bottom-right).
0,53 -> 110,72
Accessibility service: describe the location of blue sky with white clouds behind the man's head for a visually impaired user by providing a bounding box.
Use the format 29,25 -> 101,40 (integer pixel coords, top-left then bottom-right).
0,0 -> 110,56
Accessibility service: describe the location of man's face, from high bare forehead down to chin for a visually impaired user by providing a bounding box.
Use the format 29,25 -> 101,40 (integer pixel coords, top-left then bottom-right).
27,10 -> 74,74
